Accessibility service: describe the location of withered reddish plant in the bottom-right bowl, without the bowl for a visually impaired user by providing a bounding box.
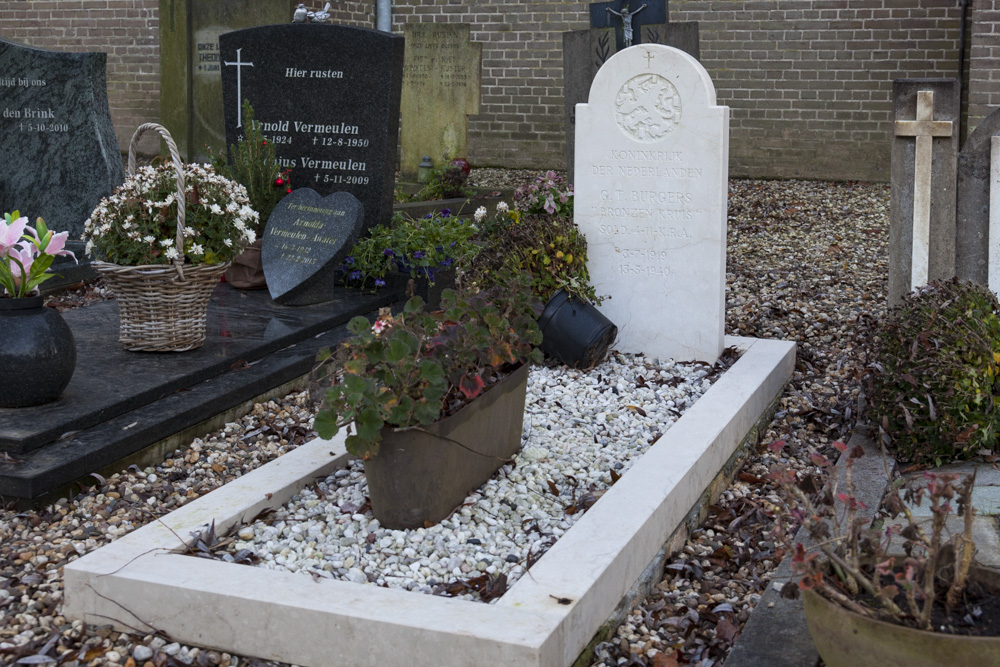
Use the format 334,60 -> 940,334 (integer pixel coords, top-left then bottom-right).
771,441 -> 975,630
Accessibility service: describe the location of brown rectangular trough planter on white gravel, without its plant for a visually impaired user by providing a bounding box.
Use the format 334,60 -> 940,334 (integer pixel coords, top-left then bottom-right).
365,364 -> 529,530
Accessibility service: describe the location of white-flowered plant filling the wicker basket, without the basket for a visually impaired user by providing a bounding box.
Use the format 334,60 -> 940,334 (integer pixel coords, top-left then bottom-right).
83,164 -> 258,266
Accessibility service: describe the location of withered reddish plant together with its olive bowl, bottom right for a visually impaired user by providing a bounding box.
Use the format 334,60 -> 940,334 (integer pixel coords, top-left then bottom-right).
771,442 -> 1000,667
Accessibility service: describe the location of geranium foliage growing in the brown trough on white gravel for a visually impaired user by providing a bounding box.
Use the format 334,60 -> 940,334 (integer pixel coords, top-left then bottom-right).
315,276 -> 541,458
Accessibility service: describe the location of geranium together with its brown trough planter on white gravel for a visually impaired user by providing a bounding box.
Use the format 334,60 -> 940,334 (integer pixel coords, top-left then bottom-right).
315,276 -> 540,528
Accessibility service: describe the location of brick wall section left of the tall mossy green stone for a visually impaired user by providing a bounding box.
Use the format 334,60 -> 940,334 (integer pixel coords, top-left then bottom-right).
0,0 -> 160,151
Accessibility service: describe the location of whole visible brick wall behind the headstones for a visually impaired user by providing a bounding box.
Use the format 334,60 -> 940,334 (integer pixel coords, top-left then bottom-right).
0,0 -> 984,180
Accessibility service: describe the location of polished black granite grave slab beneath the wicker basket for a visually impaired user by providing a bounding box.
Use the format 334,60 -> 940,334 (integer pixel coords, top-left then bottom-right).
0,284 -> 401,499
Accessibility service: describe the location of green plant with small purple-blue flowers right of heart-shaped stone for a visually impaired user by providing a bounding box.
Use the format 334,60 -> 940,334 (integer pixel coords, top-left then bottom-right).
341,208 -> 479,287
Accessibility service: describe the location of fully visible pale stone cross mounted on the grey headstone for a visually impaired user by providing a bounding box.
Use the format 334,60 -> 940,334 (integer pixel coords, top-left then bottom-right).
896,90 -> 952,289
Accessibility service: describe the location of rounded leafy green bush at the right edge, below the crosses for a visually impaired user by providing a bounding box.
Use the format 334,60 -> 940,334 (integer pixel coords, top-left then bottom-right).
871,280 -> 1000,465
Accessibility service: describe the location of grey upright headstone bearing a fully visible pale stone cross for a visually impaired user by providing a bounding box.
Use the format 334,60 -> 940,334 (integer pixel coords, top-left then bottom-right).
889,79 -> 959,305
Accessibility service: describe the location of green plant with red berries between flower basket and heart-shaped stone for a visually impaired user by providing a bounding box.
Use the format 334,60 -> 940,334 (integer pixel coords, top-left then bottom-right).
212,100 -> 292,236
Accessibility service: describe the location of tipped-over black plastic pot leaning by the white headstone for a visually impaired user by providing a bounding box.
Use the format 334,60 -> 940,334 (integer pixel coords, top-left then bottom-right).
538,290 -> 618,368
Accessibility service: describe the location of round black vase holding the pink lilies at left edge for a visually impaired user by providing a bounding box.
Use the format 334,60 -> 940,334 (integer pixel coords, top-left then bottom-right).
0,296 -> 76,408
